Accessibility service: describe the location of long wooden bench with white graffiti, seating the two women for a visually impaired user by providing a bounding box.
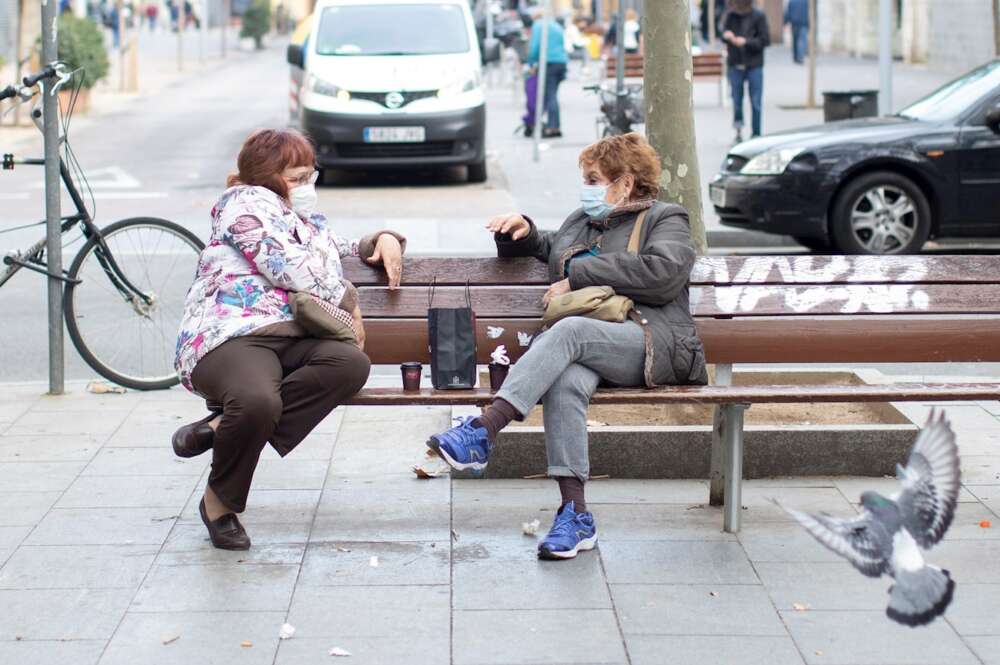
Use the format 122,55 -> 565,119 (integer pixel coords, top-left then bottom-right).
345,255 -> 1000,532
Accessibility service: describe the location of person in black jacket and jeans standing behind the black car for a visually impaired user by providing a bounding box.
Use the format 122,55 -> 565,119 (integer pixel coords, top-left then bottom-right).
722,0 -> 771,143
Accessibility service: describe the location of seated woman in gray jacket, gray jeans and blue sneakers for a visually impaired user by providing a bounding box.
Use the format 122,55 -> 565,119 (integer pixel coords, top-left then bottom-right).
428,133 -> 708,559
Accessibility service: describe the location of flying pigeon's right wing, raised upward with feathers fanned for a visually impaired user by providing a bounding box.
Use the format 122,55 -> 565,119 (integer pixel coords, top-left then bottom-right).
893,412 -> 961,549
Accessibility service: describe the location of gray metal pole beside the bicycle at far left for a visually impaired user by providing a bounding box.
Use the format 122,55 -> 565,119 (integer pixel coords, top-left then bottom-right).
42,0 -> 65,395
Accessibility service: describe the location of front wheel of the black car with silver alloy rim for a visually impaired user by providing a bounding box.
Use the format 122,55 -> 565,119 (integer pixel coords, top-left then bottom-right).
830,171 -> 931,254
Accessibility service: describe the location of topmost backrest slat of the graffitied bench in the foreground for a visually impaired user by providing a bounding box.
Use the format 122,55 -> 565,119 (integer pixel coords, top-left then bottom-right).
344,255 -> 1000,286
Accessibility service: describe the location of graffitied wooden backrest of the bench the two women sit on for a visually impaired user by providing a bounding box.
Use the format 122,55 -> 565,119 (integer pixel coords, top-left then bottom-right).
344,255 -> 1000,364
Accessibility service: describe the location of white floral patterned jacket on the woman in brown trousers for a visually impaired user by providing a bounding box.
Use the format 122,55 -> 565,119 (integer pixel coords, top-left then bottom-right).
174,185 -> 374,391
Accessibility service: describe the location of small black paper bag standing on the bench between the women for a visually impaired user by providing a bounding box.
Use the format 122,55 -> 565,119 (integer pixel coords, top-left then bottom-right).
427,283 -> 476,390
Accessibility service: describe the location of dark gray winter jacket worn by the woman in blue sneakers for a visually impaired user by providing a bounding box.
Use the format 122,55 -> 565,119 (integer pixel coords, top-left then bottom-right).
496,201 -> 708,388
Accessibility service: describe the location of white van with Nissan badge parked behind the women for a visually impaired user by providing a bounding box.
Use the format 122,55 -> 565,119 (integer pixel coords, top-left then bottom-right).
288,0 -> 486,182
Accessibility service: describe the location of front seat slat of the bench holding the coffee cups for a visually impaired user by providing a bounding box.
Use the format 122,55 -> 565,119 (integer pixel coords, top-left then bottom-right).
348,383 -> 1000,406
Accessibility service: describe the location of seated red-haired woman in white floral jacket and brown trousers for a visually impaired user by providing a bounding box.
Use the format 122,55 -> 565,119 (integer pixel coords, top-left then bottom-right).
173,130 -> 406,549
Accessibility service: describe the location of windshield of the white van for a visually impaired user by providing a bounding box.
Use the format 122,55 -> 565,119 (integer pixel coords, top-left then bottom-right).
316,3 -> 470,56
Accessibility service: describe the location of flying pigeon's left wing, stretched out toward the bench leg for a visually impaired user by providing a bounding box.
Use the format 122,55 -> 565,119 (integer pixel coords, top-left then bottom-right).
785,508 -> 892,577
